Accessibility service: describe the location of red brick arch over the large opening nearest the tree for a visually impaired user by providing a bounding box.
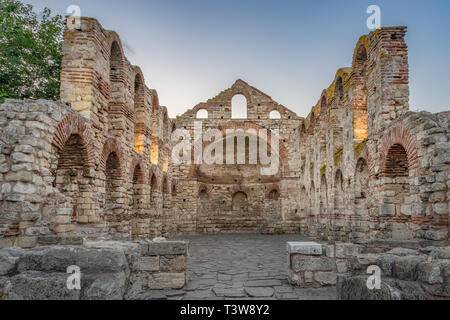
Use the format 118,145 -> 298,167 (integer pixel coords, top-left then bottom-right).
52,113 -> 95,167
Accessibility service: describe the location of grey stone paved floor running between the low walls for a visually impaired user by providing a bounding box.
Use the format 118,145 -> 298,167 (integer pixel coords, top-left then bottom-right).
149,235 -> 336,300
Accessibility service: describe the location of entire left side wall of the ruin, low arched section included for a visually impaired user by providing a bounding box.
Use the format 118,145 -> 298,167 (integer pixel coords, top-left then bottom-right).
0,18 -> 179,247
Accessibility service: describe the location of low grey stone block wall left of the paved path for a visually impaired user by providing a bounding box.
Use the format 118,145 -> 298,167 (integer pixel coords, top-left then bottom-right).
0,241 -> 188,300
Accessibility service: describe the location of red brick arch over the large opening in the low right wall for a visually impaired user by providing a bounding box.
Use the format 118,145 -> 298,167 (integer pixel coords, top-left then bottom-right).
379,126 -> 420,174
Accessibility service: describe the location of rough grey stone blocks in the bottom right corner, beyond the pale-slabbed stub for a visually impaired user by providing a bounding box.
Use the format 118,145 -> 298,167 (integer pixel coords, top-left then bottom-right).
337,247 -> 450,300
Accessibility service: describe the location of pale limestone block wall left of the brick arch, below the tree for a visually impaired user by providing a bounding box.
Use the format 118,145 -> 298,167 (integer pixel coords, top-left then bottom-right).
0,100 -> 74,247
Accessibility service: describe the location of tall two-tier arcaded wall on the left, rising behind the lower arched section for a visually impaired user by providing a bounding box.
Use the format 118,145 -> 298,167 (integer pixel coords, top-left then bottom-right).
57,18 -> 177,236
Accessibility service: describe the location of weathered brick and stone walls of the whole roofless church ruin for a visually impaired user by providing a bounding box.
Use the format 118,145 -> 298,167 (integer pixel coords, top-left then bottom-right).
0,18 -> 450,247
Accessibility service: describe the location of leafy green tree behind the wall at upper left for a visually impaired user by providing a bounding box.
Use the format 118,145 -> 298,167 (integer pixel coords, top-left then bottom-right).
0,0 -> 64,102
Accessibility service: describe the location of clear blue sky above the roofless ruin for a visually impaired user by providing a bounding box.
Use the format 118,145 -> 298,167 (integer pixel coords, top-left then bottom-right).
24,0 -> 450,117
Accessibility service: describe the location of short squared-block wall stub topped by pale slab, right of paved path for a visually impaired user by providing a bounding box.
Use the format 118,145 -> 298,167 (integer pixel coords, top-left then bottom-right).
287,242 -> 361,288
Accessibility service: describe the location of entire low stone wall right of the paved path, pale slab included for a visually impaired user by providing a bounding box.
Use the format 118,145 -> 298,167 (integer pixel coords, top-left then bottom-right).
287,240 -> 450,300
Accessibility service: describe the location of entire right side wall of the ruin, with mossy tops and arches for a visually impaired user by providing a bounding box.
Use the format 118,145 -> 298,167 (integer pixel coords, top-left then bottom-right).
300,27 -> 449,243
